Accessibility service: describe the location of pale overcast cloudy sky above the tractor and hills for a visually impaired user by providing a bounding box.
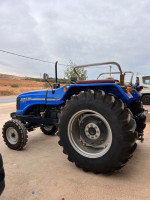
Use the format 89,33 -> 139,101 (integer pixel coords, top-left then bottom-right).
0,0 -> 150,79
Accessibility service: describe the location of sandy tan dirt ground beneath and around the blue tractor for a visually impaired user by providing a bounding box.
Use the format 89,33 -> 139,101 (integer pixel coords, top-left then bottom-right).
0,103 -> 150,200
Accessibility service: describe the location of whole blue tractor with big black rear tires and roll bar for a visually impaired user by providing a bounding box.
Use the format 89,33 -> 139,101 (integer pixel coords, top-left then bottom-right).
2,62 -> 147,173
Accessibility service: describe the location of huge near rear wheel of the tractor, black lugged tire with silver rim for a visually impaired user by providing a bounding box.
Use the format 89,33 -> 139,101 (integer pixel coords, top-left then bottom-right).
58,90 -> 136,173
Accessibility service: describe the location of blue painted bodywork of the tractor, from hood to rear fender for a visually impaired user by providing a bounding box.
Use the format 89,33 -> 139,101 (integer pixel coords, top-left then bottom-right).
17,83 -> 139,114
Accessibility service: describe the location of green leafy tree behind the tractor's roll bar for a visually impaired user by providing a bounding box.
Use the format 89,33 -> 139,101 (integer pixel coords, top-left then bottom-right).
64,61 -> 88,80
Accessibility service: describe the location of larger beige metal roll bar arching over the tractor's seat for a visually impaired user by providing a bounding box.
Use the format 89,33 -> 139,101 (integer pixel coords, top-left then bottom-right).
74,62 -> 124,85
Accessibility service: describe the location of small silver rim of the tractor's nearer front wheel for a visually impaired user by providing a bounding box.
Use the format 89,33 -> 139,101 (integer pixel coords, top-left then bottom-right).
6,127 -> 18,144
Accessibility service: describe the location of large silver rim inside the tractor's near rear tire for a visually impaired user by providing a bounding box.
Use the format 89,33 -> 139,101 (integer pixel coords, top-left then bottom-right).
68,110 -> 112,158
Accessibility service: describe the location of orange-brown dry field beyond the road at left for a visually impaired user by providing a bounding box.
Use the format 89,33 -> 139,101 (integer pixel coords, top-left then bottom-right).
0,76 -> 45,96
